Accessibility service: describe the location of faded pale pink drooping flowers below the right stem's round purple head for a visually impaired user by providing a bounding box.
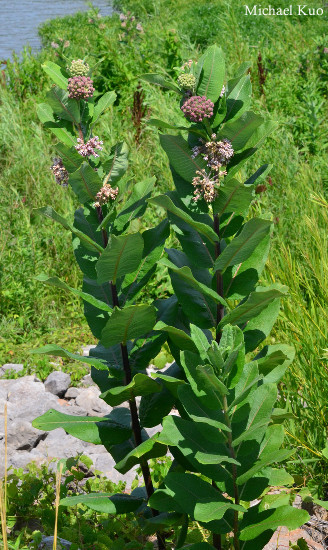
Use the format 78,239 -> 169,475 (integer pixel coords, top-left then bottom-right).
192,134 -> 234,203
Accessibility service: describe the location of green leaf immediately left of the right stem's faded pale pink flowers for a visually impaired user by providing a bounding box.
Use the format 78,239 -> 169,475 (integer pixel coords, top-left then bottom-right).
160,134 -> 207,182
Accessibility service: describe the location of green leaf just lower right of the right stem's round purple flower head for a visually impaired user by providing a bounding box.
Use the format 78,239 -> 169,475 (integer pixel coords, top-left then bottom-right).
218,111 -> 264,151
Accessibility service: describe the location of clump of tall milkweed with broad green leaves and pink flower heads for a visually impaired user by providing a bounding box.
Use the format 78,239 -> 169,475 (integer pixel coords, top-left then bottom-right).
33,46 -> 309,550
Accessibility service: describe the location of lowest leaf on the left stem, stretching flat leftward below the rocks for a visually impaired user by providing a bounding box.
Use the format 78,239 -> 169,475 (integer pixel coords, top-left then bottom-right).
59,493 -> 144,514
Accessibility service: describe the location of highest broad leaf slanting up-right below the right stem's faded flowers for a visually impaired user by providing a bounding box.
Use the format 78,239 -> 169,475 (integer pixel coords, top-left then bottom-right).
214,218 -> 272,273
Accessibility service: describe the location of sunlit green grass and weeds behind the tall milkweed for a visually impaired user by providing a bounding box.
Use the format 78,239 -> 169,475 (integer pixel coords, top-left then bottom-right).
0,0 -> 328,497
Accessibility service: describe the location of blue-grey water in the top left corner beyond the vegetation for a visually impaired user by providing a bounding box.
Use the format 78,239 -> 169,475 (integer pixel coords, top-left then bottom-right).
0,0 -> 112,60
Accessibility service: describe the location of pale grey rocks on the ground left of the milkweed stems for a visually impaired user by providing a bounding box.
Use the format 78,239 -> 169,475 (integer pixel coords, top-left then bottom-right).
0,364 -> 147,485
